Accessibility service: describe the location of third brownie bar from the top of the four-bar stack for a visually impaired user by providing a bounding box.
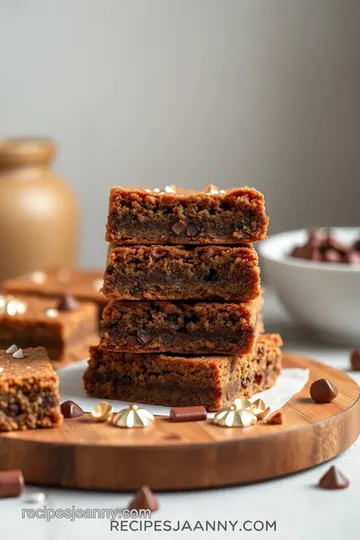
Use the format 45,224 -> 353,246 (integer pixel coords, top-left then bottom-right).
100,297 -> 262,354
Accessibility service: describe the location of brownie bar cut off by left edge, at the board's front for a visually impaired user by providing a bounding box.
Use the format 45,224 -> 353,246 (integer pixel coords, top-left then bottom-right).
0,347 -> 63,431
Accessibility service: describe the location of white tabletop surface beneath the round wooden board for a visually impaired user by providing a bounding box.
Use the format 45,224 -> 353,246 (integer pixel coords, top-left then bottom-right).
0,293 -> 360,540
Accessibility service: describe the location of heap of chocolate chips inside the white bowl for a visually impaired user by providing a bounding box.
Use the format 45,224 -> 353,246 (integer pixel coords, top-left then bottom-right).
290,228 -> 360,264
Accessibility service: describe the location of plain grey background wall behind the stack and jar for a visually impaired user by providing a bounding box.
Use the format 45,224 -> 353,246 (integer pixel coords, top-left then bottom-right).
0,0 -> 360,266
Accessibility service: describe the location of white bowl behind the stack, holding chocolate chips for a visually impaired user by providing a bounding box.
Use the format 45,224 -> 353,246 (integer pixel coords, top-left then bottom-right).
258,227 -> 360,346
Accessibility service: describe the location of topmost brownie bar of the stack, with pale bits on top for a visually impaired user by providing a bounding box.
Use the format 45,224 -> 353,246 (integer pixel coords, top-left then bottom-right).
106,186 -> 269,244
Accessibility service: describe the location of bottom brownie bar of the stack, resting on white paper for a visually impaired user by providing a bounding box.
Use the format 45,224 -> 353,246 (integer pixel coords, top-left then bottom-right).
84,334 -> 282,411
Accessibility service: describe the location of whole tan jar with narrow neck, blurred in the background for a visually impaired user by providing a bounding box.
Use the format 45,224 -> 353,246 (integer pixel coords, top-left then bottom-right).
0,139 -> 78,284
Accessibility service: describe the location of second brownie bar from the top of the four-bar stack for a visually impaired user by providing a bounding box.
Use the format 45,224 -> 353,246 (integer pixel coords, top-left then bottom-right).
102,245 -> 261,301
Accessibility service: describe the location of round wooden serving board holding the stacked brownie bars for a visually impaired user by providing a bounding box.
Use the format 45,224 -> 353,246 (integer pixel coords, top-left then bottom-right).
0,353 -> 360,491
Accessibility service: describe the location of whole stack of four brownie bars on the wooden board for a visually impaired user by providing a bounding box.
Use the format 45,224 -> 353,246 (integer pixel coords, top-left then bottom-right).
84,186 -> 281,411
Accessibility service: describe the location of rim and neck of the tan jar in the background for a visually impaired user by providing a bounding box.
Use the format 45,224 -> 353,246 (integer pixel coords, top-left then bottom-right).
0,137 -> 55,165
